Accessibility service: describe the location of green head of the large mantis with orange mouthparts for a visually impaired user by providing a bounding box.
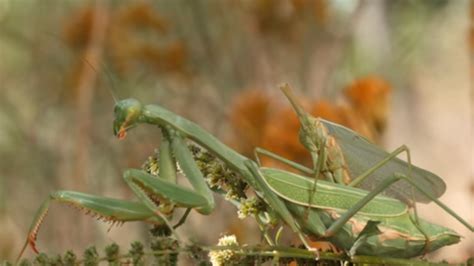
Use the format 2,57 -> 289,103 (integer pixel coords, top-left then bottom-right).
114,99 -> 142,139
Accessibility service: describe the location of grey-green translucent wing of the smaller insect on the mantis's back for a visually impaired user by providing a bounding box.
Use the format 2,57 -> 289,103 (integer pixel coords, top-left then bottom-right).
321,119 -> 446,203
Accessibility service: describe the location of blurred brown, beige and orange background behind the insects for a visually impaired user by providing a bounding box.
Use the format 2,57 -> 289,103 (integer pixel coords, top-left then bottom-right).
0,0 -> 474,262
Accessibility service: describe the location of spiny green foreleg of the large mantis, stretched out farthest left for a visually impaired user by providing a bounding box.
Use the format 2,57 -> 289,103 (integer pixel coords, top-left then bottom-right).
17,191 -> 163,262
